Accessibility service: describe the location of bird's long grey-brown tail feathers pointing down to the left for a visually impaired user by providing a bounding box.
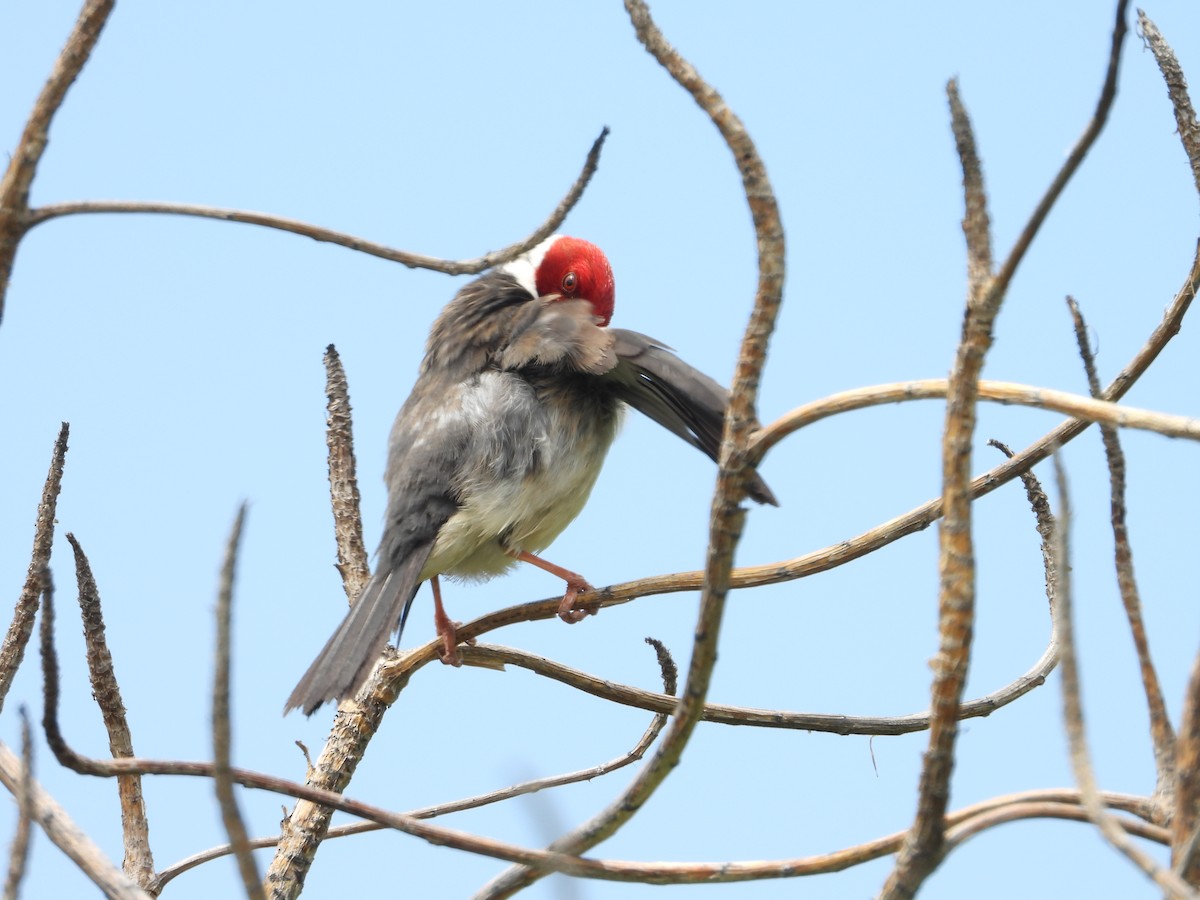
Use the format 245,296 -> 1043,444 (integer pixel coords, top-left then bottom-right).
283,546 -> 431,715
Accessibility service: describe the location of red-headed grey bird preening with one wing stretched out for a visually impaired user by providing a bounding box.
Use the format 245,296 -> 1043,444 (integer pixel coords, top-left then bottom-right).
284,234 -> 778,715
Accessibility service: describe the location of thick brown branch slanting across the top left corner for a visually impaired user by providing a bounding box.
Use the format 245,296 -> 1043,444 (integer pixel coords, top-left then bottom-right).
0,0 -> 115,319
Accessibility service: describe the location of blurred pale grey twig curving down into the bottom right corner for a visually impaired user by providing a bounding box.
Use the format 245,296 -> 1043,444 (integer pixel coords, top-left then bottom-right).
1054,454 -> 1200,898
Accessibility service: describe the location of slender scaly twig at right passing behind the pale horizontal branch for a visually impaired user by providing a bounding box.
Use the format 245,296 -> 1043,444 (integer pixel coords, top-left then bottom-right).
1067,296 -> 1175,824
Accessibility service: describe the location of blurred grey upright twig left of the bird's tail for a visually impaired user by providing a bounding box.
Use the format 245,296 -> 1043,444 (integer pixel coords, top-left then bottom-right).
212,511 -> 266,900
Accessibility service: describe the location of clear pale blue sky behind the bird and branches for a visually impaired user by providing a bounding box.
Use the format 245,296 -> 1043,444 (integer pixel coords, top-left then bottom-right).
0,0 -> 1200,900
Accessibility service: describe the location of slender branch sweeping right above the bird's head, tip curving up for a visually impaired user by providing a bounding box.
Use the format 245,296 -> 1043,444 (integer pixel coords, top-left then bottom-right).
23,128 -> 608,275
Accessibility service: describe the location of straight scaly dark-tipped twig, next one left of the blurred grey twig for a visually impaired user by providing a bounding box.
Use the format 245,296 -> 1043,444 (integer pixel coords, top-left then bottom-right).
67,532 -> 154,889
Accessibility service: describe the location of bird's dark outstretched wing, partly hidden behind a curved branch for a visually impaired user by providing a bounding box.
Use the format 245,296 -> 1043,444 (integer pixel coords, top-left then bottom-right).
604,328 -> 779,506
